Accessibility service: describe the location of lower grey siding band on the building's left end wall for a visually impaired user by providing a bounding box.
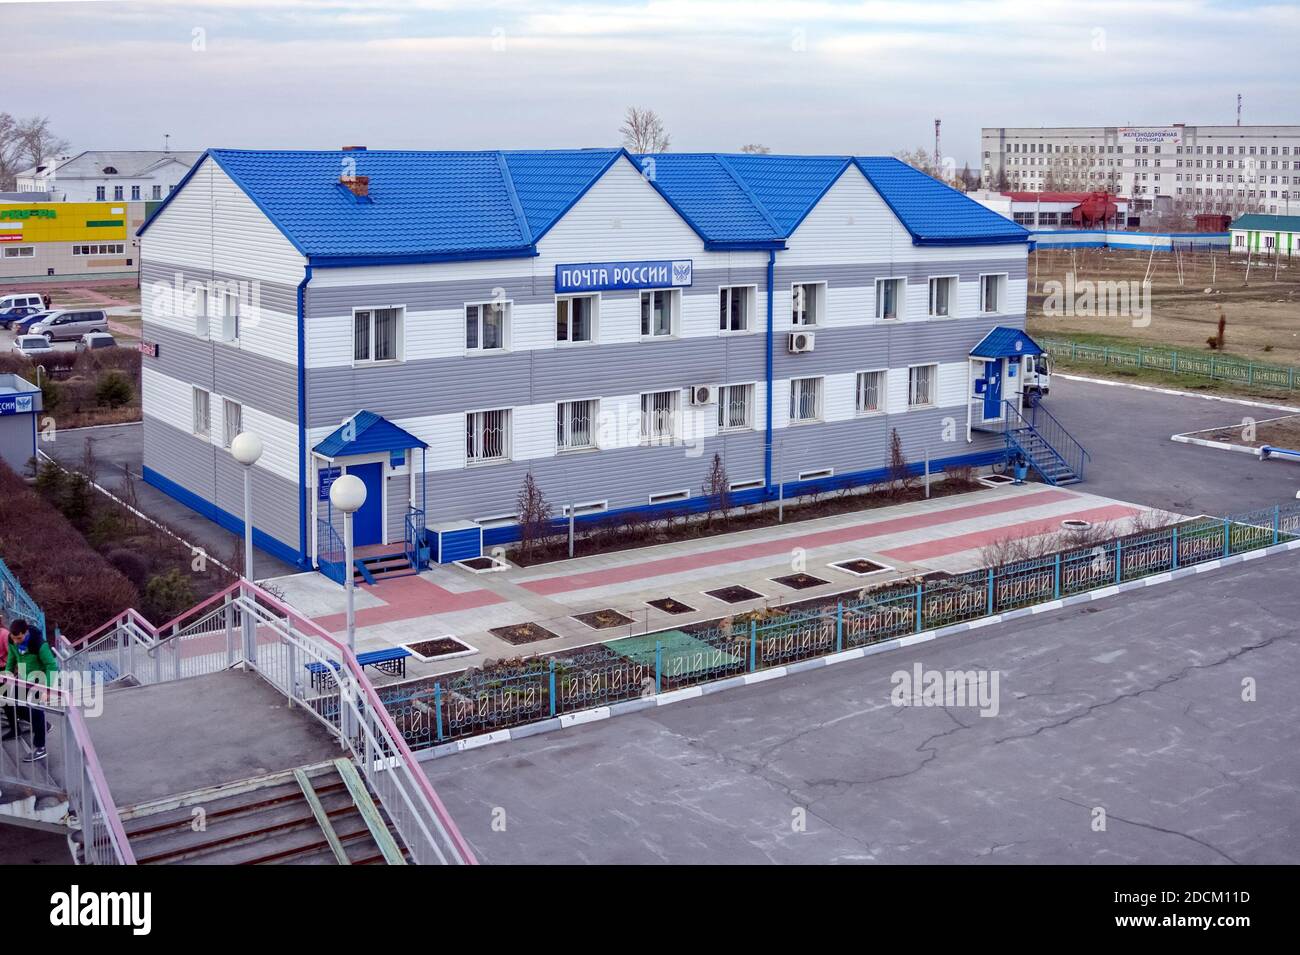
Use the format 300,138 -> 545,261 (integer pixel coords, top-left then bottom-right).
142,414 -> 298,548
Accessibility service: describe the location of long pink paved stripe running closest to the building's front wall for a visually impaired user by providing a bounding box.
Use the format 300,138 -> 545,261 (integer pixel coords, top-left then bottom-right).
520,489 -> 1076,596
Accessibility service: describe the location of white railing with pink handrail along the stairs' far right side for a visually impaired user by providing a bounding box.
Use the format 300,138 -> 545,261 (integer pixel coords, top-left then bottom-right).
61,579 -> 475,864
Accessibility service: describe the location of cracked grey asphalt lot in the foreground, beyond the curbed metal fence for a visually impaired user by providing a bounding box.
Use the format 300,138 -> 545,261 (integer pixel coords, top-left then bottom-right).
425,554 -> 1300,864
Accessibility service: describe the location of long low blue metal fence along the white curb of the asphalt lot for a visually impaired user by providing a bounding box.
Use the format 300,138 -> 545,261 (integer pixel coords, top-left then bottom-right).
380,502 -> 1300,747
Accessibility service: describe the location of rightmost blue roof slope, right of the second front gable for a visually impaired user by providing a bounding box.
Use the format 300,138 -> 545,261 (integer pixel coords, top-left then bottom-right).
857,156 -> 1030,246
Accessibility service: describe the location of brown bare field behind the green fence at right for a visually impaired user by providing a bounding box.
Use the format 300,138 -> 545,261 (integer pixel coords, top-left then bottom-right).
1028,249 -> 1300,365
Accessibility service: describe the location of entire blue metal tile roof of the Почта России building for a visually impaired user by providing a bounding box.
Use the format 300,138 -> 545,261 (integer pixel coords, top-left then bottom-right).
139,149 -> 1028,259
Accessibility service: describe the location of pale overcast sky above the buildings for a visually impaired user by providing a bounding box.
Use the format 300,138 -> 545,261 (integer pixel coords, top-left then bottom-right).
0,0 -> 1300,166
